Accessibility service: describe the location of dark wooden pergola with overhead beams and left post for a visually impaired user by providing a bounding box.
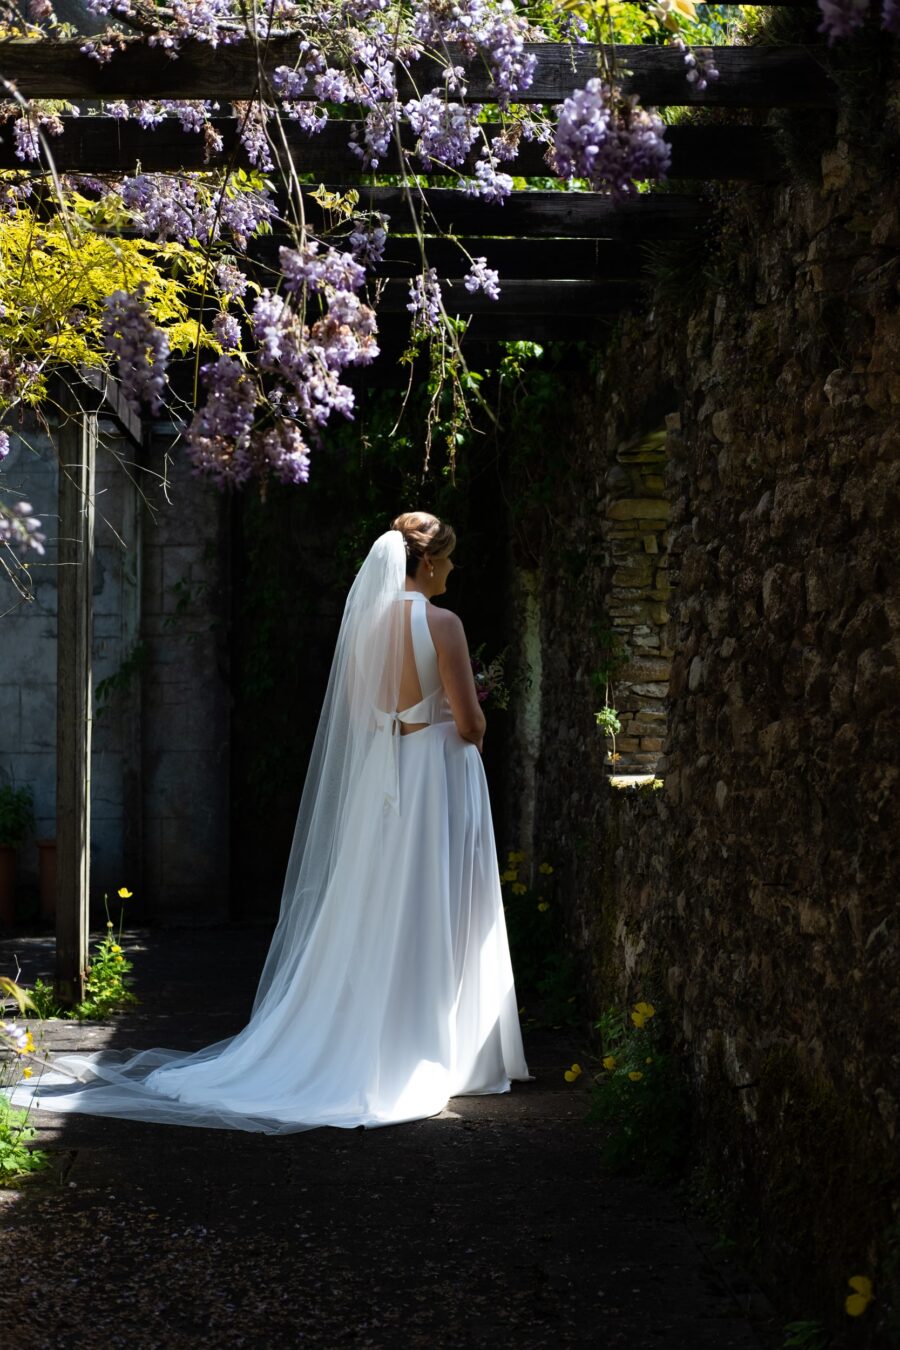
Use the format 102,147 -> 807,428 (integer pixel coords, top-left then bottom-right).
0,0 -> 837,1003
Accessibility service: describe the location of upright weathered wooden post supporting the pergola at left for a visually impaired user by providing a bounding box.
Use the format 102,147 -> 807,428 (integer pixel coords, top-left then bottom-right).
55,385 -> 97,1007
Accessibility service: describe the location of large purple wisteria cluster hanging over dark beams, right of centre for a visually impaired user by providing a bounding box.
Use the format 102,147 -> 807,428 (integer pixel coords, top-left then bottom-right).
553,80 -> 672,198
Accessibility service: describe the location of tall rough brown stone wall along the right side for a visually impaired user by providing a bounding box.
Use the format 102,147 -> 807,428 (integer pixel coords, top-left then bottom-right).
518,71 -> 900,1345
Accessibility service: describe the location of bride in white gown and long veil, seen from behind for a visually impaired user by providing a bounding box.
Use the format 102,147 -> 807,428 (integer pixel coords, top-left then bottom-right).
13,512 -> 529,1134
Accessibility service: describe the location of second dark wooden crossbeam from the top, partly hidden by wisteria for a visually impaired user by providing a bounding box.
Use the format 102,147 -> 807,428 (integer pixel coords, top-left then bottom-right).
0,116 -> 784,185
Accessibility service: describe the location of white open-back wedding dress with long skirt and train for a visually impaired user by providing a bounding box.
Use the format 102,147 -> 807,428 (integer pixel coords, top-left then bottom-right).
8,590 -> 529,1134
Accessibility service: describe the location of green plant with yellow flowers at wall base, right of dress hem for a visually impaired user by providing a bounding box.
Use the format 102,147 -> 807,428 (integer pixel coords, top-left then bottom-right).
590,1002 -> 690,1180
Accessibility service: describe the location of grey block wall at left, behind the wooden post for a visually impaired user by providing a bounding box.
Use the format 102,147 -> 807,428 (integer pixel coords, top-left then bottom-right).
0,419 -> 229,922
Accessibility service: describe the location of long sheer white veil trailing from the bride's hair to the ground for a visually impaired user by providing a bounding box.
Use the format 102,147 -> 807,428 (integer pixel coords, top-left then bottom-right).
13,529 -> 418,1134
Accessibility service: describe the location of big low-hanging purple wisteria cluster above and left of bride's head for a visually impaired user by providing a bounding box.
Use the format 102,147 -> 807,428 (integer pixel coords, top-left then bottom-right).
185,239 -> 378,486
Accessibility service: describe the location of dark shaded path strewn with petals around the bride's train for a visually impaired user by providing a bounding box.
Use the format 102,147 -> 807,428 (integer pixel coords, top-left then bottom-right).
0,927 -> 780,1350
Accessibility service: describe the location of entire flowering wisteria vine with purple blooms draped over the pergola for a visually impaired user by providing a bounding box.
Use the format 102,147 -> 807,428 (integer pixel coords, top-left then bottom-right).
0,0 -> 900,534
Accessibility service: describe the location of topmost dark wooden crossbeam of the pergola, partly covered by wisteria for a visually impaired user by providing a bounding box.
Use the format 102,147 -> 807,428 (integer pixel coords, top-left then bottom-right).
0,36 -> 837,108
